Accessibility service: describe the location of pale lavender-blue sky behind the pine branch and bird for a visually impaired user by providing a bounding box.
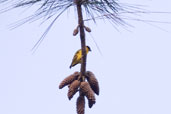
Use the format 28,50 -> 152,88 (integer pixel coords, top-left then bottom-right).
0,0 -> 171,114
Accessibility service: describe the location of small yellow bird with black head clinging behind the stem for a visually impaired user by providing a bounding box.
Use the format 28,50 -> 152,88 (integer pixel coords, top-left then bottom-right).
69,46 -> 91,68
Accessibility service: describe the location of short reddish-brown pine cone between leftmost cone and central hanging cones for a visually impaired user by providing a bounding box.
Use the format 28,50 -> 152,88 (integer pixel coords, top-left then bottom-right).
68,80 -> 80,100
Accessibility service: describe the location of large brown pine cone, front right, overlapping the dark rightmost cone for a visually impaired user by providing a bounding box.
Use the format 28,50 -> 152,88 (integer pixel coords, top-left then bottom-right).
80,82 -> 96,108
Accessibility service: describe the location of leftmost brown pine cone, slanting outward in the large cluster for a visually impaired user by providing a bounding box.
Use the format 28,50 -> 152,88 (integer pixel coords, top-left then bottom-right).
59,72 -> 79,89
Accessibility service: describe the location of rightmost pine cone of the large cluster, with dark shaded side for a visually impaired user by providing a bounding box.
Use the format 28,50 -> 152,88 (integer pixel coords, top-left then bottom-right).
86,71 -> 99,95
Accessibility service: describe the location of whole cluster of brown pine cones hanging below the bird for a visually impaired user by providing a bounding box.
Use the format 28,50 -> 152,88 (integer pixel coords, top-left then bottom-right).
59,71 -> 99,114
